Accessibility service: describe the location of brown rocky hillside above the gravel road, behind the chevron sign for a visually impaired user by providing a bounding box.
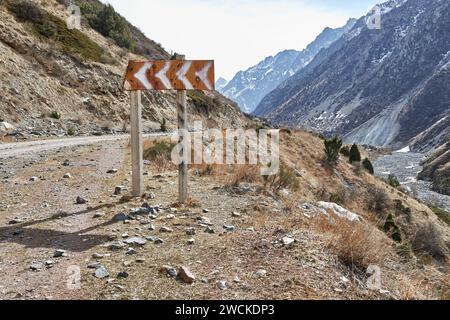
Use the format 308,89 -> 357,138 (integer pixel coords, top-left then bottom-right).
0,0 -> 247,139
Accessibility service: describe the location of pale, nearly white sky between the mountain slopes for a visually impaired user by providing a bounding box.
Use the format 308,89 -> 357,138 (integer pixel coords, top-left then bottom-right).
102,0 -> 383,81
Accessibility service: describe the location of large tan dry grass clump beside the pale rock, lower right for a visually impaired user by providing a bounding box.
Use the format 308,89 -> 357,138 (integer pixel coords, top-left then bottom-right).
315,217 -> 391,271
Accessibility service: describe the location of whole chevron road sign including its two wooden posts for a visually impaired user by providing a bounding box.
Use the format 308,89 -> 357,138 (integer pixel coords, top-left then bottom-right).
123,55 -> 215,202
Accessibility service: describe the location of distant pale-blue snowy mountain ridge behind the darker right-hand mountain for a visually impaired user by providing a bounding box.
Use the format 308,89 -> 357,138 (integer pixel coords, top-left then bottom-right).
220,19 -> 356,113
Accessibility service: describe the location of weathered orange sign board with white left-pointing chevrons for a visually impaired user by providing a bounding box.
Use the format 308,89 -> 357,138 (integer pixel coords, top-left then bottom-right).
123,60 -> 215,91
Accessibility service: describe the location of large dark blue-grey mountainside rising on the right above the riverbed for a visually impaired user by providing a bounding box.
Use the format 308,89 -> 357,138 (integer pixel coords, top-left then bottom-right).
255,0 -> 450,148
